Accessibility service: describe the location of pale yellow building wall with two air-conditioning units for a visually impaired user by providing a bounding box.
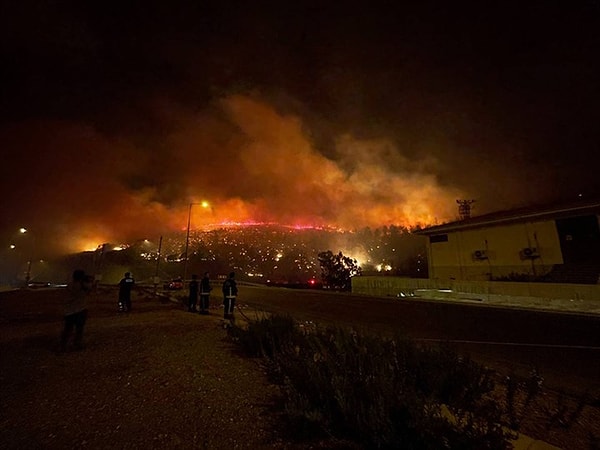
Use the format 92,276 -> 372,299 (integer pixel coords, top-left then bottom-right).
428,221 -> 563,280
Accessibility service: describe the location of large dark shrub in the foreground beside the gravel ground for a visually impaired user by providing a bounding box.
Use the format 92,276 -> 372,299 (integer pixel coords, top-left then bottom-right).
231,316 -> 513,449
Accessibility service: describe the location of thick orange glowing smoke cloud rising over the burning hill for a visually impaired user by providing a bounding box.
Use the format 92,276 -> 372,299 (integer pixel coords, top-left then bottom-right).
2,95 -> 460,251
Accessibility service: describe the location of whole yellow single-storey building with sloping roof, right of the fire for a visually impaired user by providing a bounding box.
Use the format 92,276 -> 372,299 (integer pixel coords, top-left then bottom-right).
416,200 -> 600,284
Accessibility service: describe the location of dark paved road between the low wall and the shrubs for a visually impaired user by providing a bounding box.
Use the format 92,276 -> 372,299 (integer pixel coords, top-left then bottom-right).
239,286 -> 600,394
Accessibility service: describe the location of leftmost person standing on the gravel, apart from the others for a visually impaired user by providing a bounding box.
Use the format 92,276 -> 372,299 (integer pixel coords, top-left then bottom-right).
60,269 -> 94,352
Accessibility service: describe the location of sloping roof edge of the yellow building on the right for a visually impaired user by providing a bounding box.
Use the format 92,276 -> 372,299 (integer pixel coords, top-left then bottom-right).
414,199 -> 600,236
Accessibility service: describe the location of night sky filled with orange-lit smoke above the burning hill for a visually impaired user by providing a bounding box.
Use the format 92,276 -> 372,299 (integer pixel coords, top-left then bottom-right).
0,0 -> 600,255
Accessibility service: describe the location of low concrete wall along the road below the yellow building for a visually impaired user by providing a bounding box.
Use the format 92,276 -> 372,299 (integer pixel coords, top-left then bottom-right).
352,277 -> 600,302
